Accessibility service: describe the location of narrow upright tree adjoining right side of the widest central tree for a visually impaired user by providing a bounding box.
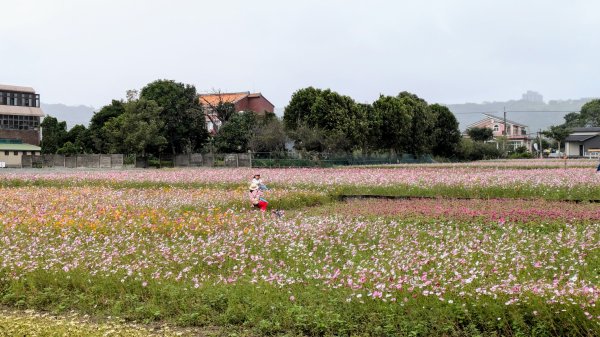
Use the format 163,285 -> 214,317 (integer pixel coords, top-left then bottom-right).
373,95 -> 412,153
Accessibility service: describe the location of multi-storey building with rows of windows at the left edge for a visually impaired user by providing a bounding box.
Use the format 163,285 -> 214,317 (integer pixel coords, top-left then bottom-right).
0,84 -> 44,146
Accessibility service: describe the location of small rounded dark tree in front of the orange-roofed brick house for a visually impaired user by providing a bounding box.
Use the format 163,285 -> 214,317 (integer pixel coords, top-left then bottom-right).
214,111 -> 256,153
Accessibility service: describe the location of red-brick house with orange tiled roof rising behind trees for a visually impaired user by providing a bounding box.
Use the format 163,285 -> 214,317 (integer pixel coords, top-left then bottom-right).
199,91 -> 275,134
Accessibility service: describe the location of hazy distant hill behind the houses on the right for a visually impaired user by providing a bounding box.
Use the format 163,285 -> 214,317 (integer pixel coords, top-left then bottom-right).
446,95 -> 594,133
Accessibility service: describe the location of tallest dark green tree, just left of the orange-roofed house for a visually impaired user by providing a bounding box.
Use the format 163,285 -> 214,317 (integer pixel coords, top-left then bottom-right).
140,80 -> 208,154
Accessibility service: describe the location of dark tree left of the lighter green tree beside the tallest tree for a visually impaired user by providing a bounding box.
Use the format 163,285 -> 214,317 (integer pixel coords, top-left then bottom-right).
84,100 -> 125,153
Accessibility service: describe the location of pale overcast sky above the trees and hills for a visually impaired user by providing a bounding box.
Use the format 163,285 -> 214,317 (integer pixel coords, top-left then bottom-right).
0,0 -> 600,108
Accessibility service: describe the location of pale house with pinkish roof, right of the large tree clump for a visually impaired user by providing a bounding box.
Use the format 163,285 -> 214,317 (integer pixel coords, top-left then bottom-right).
467,113 -> 531,150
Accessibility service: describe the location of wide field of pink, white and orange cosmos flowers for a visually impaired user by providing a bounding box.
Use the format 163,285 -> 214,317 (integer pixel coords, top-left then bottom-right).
0,168 -> 600,336
